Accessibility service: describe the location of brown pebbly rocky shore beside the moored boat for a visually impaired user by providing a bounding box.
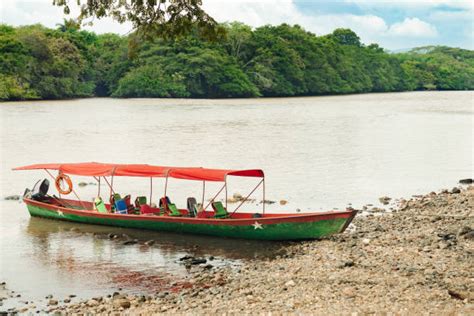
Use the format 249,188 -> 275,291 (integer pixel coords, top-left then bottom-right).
3,186 -> 474,315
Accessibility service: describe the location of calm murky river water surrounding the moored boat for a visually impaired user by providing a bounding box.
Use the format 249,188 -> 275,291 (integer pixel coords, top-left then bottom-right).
0,92 -> 474,310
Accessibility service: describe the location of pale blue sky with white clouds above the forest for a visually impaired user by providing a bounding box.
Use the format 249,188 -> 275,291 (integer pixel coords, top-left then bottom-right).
0,0 -> 474,50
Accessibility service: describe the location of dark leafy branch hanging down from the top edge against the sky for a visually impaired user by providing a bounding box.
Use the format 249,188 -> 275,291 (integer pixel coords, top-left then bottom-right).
53,0 -> 224,39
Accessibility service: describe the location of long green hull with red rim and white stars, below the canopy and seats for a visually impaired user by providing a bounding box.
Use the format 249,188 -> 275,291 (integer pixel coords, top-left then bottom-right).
24,199 -> 357,240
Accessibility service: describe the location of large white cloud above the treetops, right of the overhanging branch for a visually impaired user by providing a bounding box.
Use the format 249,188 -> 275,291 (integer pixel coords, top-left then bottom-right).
204,0 -> 440,43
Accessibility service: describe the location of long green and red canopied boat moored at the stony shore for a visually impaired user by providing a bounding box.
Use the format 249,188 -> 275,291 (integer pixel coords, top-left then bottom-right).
13,162 -> 357,240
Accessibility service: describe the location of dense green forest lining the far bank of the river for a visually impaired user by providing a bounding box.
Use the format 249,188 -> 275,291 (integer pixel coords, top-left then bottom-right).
0,21 -> 474,100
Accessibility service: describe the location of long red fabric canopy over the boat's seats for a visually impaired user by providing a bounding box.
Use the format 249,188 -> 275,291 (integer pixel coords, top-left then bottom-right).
13,162 -> 264,181
